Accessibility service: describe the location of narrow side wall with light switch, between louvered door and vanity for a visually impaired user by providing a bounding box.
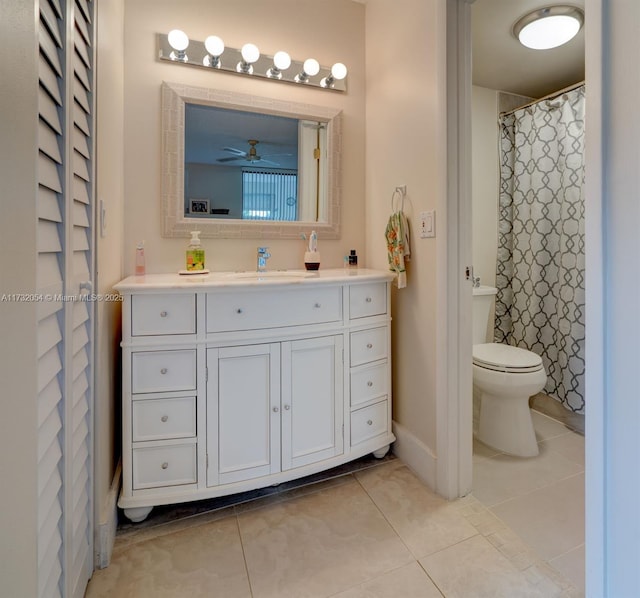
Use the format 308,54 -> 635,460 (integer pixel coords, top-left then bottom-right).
94,0 -> 124,564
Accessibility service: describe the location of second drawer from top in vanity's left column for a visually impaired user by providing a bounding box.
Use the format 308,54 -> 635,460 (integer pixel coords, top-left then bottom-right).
131,349 -> 196,394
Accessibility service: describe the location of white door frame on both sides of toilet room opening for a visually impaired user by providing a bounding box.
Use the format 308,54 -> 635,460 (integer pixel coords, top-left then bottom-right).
437,0 -> 606,596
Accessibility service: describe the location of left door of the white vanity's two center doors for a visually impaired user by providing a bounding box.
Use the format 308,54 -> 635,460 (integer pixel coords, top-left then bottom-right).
207,343 -> 280,486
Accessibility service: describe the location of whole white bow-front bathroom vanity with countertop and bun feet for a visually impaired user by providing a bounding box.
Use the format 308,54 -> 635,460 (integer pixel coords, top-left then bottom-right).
115,269 -> 395,521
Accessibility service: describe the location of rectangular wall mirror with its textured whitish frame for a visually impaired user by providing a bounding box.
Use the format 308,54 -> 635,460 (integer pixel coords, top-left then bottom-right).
162,82 -> 341,239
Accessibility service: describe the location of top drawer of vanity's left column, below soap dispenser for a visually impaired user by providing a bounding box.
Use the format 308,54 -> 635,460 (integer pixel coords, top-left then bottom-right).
131,293 -> 196,336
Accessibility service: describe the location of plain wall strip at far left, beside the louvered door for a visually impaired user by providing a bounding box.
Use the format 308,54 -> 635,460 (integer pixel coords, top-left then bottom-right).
0,0 -> 38,596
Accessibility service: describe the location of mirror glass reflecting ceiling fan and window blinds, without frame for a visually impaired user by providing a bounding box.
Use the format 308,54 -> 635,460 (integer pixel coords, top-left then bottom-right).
184,103 -> 327,222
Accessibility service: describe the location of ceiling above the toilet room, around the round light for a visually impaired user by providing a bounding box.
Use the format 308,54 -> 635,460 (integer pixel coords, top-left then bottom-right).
471,0 -> 588,98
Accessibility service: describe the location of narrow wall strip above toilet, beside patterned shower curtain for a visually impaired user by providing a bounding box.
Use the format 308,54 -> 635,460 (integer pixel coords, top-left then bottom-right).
471,86 -> 500,286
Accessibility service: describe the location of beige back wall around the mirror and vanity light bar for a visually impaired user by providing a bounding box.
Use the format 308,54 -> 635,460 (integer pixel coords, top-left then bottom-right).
124,0 -> 370,274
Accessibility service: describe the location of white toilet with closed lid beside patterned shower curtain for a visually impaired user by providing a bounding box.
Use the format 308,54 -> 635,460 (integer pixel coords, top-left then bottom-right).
473,286 -> 547,457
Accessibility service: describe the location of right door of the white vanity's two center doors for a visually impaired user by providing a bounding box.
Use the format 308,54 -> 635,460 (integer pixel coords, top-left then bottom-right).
282,335 -> 344,470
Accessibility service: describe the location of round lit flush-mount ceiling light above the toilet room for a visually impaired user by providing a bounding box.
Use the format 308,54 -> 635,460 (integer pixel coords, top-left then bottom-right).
513,5 -> 584,50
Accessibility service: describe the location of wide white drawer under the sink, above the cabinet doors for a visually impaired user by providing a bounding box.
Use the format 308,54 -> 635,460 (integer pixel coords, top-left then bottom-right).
207,287 -> 342,332
